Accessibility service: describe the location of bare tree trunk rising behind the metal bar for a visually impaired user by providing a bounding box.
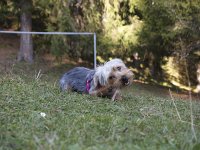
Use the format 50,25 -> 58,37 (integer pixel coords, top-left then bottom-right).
17,0 -> 33,63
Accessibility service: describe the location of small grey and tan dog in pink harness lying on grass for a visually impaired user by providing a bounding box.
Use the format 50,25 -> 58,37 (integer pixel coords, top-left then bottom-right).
59,58 -> 133,100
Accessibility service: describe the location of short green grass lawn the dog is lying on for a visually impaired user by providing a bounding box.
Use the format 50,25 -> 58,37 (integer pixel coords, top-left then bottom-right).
0,61 -> 200,150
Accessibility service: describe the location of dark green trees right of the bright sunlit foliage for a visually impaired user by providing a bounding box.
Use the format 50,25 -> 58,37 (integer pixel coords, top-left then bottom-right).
128,0 -> 200,85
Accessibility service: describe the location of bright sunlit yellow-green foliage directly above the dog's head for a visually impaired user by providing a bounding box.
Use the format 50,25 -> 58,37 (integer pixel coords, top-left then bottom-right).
99,0 -> 142,58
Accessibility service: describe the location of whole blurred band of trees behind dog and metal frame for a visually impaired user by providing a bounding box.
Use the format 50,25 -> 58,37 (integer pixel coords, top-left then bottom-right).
0,0 -> 200,89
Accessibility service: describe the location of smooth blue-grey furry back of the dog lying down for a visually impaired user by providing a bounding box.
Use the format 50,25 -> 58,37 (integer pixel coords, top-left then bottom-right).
60,67 -> 94,93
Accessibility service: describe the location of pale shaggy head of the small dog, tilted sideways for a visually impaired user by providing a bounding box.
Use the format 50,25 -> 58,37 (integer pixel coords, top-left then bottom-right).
94,59 -> 133,88
